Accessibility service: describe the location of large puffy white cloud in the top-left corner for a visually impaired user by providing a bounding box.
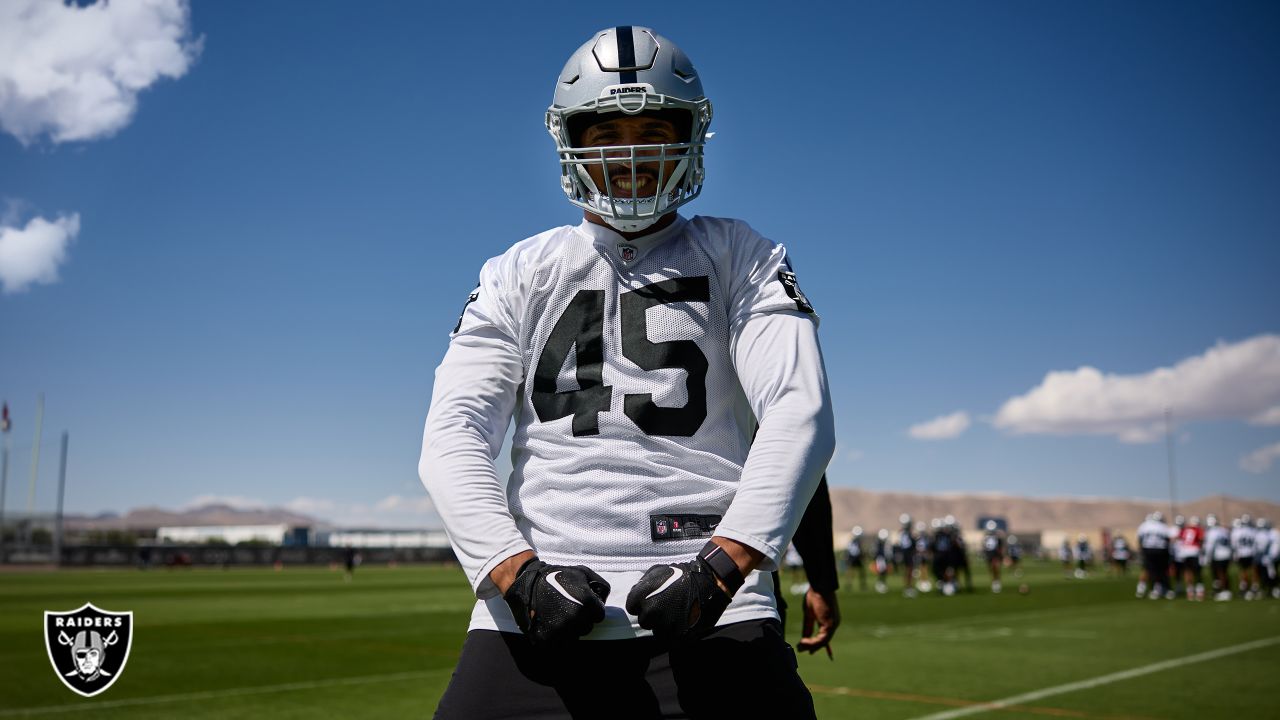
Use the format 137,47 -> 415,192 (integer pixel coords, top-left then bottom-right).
0,0 -> 201,145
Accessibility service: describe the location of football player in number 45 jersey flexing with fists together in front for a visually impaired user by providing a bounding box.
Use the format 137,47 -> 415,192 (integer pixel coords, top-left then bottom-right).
419,26 -> 835,719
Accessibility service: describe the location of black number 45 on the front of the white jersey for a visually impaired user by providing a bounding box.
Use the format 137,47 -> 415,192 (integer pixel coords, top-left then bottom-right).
532,277 -> 710,437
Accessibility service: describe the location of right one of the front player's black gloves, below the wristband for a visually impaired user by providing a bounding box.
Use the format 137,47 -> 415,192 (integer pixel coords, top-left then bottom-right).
627,557 -> 733,641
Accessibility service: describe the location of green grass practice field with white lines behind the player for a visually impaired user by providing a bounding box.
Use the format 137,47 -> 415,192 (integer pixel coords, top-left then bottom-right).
0,565 -> 1280,720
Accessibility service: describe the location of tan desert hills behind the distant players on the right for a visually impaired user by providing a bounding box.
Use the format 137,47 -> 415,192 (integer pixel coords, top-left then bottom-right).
831,488 -> 1280,538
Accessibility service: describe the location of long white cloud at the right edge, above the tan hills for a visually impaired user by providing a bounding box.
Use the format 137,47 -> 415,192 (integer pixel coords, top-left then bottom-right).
992,334 -> 1280,442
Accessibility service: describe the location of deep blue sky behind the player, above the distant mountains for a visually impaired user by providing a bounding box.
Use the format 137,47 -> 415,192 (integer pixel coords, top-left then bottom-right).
0,1 -> 1280,524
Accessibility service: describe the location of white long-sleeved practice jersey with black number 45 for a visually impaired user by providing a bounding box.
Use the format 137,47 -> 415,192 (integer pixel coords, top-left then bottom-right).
420,211 -> 835,639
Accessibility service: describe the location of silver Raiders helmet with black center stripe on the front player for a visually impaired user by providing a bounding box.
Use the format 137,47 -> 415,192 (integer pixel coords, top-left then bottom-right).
547,26 -> 712,232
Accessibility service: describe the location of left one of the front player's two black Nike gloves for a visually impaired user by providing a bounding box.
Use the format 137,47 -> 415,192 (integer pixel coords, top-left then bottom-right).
502,557 -> 609,644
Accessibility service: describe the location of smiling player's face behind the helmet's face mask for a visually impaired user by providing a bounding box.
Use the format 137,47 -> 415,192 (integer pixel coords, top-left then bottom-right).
581,114 -> 684,197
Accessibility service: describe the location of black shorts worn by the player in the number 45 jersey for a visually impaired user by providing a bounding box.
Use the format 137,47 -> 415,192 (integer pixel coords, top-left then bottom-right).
435,620 -> 814,720
